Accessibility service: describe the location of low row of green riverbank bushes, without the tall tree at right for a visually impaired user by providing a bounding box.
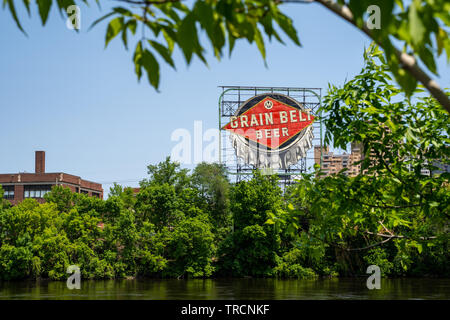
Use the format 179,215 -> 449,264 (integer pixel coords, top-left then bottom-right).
0,159 -> 449,280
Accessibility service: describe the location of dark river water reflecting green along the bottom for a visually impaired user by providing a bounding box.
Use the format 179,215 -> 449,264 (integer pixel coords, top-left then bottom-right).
0,278 -> 450,300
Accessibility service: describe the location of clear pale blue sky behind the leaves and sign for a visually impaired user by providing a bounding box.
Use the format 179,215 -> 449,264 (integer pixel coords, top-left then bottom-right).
0,1 -> 450,195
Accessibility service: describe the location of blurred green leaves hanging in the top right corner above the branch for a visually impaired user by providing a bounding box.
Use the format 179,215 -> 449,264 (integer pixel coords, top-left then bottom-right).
340,0 -> 450,96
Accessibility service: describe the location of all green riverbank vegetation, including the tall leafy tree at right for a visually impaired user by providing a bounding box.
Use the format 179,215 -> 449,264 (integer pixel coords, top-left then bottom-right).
0,47 -> 450,280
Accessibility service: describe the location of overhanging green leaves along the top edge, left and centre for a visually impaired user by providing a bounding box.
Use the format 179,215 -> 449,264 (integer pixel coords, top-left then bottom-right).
5,0 -> 300,89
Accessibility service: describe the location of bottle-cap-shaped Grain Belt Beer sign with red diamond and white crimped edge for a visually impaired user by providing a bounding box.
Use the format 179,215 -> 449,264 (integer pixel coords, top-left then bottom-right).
222,93 -> 314,169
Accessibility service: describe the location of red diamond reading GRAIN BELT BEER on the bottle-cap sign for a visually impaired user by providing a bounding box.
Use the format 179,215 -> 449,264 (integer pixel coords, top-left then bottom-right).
222,94 -> 314,149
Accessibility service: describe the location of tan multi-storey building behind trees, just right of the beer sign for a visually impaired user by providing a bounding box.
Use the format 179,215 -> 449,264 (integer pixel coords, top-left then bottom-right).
314,143 -> 363,177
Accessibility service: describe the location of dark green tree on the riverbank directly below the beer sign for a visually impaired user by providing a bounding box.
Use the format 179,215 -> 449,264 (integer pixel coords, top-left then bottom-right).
219,171 -> 283,276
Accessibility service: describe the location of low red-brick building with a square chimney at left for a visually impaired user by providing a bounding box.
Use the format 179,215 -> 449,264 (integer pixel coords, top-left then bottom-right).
0,151 -> 103,204
